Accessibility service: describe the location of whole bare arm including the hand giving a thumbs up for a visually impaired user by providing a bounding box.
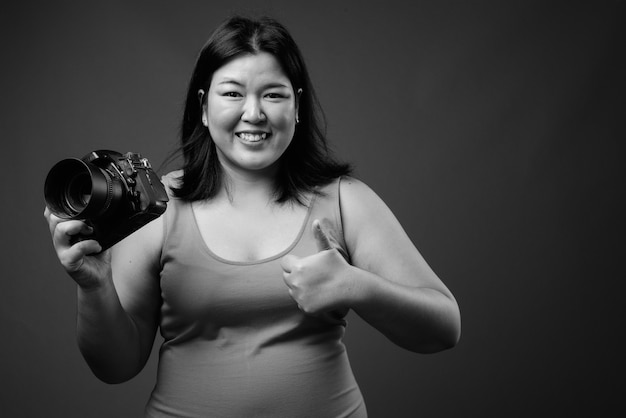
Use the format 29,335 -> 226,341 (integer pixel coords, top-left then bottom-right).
282,179 -> 461,353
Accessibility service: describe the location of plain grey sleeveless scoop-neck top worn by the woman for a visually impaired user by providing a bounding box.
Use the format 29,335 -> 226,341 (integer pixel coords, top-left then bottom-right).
145,178 -> 367,418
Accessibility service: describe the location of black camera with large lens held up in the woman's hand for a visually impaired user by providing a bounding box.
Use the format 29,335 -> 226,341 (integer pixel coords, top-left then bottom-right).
44,150 -> 169,251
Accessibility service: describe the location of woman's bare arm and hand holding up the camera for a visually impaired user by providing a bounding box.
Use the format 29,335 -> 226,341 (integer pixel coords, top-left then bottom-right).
45,209 -> 162,383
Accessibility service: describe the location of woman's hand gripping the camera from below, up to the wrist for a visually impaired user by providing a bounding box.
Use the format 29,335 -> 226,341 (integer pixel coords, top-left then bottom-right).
44,206 -> 111,290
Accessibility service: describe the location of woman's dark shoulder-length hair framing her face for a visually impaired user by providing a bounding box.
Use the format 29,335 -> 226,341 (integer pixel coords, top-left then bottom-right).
168,16 -> 351,203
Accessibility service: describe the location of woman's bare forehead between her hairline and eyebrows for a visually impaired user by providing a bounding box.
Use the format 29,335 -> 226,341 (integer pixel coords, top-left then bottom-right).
211,52 -> 291,86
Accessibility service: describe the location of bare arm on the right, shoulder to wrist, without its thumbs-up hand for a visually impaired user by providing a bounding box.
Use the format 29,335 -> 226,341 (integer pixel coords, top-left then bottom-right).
341,179 -> 461,353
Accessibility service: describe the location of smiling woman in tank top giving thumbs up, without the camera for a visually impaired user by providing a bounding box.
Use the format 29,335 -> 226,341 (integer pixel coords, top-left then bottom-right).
45,17 -> 460,417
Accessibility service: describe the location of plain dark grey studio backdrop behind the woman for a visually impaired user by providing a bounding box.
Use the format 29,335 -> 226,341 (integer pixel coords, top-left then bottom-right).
0,0 -> 626,417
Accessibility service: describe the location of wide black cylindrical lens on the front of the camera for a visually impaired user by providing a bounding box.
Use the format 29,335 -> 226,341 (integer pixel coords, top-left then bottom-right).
44,158 -> 123,219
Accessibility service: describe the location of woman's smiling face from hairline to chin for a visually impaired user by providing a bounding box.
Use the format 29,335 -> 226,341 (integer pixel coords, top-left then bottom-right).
203,52 -> 298,174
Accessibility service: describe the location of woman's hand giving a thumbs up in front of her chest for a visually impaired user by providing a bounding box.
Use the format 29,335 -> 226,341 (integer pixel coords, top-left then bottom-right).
281,219 -> 352,316
